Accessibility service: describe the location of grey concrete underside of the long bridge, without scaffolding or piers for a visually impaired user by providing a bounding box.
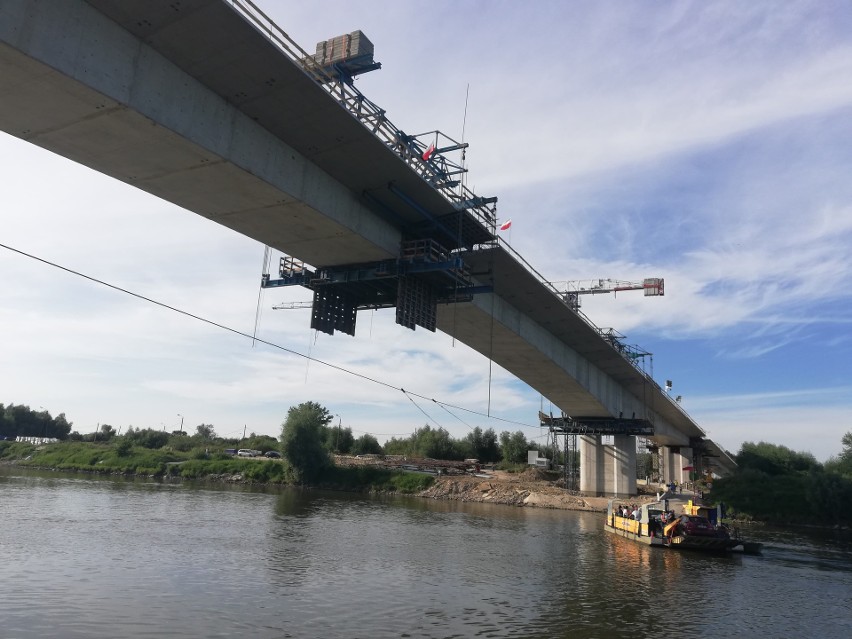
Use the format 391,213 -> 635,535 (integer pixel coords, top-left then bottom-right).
0,0 -> 736,480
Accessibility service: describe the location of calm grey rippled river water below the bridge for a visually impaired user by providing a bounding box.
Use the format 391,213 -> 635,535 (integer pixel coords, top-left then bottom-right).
0,467 -> 852,639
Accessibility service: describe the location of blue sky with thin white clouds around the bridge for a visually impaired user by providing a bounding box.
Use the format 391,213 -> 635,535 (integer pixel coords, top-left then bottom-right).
0,0 -> 852,460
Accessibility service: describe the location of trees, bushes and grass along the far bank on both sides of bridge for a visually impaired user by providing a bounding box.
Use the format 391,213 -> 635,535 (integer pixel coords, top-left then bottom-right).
0,402 -> 852,526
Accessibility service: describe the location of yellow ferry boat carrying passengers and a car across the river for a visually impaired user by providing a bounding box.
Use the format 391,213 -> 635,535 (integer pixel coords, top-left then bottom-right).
604,499 -> 760,554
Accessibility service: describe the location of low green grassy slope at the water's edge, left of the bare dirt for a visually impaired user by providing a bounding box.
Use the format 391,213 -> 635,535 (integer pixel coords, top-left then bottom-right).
0,441 -> 434,494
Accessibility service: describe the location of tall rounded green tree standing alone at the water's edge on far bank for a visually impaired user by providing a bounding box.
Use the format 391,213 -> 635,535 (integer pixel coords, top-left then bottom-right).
281,402 -> 331,482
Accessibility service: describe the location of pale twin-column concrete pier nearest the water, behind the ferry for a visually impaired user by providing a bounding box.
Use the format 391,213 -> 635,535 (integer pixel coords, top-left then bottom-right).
580,435 -> 636,497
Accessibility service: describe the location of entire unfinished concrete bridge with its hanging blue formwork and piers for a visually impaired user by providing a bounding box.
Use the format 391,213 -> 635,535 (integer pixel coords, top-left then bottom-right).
0,0 -> 734,494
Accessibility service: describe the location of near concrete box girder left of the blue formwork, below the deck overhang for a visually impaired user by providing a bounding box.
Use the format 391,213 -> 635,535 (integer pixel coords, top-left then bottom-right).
0,0 -> 401,264
